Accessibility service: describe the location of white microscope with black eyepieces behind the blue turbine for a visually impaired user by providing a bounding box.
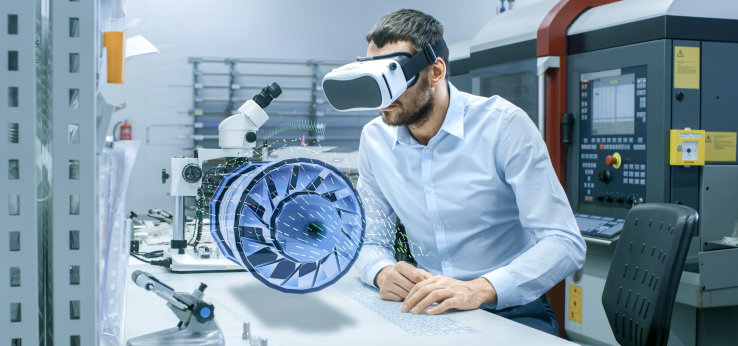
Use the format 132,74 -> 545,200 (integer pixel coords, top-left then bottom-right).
162,83 -> 282,272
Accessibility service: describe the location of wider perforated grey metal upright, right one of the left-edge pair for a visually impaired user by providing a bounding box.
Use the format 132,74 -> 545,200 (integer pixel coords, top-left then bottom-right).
49,0 -> 99,345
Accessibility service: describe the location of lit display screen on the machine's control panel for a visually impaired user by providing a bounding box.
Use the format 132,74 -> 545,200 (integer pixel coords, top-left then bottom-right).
590,73 -> 636,136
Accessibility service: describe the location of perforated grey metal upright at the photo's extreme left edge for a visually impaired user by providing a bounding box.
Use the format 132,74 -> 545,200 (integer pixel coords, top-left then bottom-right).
0,1 -> 40,345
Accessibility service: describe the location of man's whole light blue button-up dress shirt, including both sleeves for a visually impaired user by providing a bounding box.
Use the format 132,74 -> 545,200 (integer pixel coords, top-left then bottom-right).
356,83 -> 586,309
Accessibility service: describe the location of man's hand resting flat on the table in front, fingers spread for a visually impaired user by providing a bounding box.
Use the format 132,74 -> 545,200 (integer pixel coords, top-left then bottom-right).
401,275 -> 497,315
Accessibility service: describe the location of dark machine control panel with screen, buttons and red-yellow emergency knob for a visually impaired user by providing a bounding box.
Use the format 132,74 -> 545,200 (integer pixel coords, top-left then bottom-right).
579,66 -> 648,208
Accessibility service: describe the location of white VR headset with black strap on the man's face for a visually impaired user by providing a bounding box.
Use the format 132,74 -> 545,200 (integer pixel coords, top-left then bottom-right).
323,39 -> 448,111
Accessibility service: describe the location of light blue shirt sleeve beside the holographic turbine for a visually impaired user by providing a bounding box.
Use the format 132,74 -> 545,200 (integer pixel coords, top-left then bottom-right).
356,129 -> 397,287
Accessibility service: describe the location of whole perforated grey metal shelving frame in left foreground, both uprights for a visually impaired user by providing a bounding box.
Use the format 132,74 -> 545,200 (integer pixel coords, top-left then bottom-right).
0,0 -> 100,346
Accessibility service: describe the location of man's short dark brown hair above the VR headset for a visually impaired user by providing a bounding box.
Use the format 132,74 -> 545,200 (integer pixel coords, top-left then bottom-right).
366,9 -> 451,79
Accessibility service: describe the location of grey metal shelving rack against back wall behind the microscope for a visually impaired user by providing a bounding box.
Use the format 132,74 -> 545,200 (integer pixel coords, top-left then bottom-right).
189,57 -> 377,149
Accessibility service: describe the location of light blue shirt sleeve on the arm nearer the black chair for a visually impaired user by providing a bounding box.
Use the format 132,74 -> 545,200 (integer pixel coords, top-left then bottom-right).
483,109 -> 586,309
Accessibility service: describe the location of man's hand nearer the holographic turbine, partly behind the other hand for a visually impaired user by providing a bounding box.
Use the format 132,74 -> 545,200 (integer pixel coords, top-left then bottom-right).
375,262 -> 431,302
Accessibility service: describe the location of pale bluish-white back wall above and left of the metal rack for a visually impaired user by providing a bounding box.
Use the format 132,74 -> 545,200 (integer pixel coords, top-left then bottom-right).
102,0 -> 537,214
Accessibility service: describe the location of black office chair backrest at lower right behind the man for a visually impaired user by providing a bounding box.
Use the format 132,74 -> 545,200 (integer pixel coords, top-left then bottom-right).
602,203 -> 698,345
